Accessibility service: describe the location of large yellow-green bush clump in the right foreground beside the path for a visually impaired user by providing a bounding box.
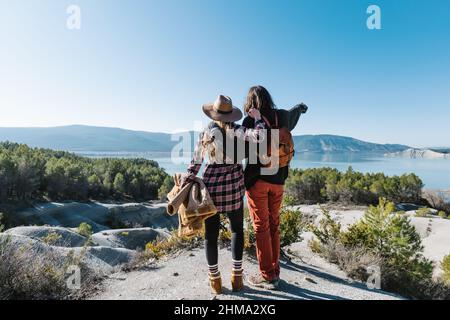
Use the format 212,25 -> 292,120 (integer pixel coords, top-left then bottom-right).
310,199 -> 446,298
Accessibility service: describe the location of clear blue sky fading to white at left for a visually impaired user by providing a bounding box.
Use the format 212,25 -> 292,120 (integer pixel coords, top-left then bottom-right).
0,0 -> 450,147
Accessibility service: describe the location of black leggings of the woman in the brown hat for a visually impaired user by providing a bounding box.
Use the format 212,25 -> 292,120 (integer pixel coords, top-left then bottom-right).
205,207 -> 244,266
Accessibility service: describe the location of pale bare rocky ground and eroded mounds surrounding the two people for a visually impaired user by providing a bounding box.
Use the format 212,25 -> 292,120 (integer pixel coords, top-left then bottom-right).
0,203 -> 450,300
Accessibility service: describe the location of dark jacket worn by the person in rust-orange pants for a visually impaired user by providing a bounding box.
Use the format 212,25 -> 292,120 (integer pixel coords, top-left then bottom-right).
242,105 -> 301,190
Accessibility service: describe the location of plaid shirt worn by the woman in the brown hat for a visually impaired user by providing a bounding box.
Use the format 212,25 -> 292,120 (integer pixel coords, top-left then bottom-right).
187,120 -> 265,213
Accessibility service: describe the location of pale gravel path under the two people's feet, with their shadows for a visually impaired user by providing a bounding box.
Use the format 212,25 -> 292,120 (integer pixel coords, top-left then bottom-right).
92,243 -> 399,300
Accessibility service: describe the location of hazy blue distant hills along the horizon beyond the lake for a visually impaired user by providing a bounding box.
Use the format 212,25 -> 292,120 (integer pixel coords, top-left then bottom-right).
0,125 -> 410,153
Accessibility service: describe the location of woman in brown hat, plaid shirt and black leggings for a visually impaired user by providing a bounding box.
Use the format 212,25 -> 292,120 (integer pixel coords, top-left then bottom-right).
182,95 -> 265,294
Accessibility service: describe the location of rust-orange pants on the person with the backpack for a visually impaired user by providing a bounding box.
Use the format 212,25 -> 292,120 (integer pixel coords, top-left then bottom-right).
246,180 -> 284,281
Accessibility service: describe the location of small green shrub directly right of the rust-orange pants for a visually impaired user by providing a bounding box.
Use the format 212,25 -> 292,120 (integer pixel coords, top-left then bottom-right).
280,209 -> 305,247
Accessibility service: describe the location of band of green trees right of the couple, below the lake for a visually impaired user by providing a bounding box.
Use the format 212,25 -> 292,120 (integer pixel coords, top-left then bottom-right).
286,167 -> 424,204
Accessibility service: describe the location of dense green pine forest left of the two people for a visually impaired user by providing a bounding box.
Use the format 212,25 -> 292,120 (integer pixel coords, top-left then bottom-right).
0,142 -> 173,202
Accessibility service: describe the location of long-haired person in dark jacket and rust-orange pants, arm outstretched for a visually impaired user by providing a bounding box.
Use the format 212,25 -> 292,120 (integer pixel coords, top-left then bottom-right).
243,86 -> 306,289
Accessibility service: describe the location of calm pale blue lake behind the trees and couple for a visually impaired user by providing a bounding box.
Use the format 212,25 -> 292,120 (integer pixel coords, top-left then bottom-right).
78,151 -> 450,190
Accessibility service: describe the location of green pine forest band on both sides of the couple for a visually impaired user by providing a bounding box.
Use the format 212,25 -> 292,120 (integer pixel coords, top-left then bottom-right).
0,142 -> 423,204
